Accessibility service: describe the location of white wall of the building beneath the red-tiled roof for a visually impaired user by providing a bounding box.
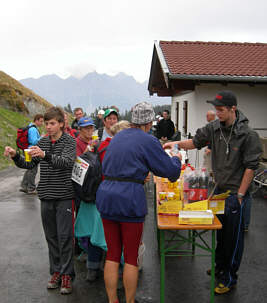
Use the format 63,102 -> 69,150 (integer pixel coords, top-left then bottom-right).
172,84 -> 267,164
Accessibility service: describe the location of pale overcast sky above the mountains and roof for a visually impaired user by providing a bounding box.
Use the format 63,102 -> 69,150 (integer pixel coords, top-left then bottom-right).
0,0 -> 267,82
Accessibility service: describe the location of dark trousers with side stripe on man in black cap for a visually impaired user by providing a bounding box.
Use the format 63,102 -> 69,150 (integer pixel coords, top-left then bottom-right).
215,195 -> 249,286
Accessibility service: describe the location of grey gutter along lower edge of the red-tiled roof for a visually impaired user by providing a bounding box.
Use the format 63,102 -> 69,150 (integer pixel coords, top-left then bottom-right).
168,73 -> 267,83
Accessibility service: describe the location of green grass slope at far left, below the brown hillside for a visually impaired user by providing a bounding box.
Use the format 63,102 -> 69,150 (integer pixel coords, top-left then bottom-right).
0,107 -> 31,170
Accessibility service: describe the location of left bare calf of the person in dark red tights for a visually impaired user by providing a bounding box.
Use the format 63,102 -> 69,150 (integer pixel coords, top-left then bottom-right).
104,260 -> 119,303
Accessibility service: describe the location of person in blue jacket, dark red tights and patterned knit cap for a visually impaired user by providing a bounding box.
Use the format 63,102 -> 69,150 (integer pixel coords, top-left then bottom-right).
96,102 -> 181,303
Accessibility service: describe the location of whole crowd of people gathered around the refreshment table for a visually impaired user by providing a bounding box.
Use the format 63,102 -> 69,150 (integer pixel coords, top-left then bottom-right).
4,91 -> 261,303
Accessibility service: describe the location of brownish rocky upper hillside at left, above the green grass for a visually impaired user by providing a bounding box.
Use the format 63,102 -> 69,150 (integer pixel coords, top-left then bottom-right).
0,71 -> 52,116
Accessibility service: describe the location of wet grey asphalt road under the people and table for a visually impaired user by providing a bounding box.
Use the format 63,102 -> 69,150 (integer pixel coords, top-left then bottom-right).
0,168 -> 267,303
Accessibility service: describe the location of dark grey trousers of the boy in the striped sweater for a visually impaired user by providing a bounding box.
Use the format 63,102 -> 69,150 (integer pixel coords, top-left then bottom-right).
41,200 -> 74,277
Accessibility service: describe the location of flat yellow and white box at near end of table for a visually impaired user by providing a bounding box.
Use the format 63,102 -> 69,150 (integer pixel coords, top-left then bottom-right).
179,210 -> 214,225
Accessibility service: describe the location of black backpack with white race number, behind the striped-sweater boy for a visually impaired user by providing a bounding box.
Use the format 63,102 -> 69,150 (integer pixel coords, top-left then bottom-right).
72,146 -> 107,203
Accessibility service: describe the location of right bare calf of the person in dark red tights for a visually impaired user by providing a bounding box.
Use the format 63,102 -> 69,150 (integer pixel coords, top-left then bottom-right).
123,263 -> 138,303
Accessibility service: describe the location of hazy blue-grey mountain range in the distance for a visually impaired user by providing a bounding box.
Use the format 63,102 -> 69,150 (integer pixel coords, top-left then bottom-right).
20,72 -> 171,113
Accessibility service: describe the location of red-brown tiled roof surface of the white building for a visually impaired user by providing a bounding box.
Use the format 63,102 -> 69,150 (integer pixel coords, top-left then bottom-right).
159,41 -> 267,77
